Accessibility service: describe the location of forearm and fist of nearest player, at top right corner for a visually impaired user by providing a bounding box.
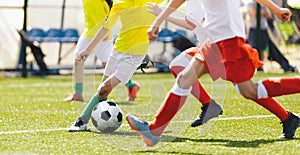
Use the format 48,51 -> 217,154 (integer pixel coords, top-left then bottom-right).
256,0 -> 292,22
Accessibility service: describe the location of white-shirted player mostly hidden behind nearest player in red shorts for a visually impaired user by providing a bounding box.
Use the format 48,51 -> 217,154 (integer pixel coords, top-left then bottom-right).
147,0 -> 223,127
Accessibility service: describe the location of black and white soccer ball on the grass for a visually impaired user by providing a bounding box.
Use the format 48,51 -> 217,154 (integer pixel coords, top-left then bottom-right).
91,101 -> 123,133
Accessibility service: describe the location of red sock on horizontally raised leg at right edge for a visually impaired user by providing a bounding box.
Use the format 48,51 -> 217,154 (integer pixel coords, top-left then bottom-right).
263,76 -> 300,97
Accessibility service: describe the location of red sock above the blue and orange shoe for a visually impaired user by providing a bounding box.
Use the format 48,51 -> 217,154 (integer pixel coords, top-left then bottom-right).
150,92 -> 187,136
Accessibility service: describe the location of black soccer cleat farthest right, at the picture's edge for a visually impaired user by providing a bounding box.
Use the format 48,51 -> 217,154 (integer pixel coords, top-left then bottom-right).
279,112 -> 300,139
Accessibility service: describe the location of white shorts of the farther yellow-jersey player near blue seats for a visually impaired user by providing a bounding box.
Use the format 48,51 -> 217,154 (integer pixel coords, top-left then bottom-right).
75,36 -> 114,63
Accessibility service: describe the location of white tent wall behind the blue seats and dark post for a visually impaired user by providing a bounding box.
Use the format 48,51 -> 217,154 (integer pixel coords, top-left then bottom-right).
0,0 -> 84,76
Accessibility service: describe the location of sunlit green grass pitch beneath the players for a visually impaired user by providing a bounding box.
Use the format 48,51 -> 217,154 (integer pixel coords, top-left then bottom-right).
0,73 -> 300,155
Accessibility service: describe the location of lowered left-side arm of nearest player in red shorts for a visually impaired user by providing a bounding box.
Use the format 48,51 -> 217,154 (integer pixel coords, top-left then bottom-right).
148,0 -> 185,40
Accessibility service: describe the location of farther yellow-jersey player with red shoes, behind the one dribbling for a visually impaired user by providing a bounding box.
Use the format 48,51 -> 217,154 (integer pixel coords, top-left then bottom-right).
64,0 -> 139,102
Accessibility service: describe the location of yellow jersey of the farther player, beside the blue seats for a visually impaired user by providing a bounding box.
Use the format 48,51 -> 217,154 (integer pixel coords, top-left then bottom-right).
82,0 -> 111,40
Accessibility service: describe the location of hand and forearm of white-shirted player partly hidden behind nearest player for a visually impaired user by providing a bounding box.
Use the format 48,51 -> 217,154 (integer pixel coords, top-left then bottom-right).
147,2 -> 194,30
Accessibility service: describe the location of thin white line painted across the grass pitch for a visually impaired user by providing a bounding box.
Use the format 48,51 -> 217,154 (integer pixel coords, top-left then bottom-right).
0,115 -> 274,135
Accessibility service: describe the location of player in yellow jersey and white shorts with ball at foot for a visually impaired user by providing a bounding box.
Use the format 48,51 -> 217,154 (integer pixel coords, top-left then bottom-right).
69,0 -> 163,132
